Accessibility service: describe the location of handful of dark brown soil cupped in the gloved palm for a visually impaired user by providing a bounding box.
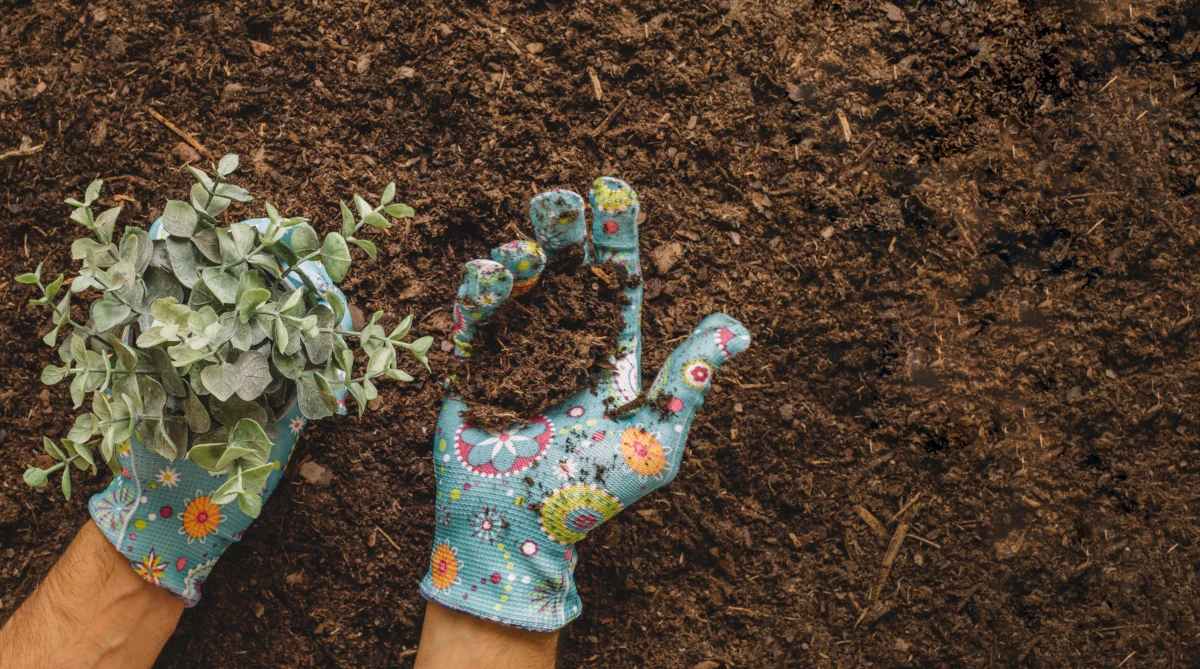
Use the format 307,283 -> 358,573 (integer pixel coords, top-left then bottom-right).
452,247 -> 636,430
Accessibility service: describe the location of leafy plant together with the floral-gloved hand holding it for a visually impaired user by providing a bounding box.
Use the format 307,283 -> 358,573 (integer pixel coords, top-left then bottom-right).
17,155 -> 432,604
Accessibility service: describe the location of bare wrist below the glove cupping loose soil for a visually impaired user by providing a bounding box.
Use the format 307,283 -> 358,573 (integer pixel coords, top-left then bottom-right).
414,602 -> 558,669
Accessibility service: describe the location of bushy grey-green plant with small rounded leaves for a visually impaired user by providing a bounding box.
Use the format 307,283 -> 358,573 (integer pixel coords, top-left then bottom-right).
16,155 -> 433,517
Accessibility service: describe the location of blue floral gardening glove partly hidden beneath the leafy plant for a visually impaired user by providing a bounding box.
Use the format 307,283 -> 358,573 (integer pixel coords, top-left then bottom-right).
88,218 -> 353,607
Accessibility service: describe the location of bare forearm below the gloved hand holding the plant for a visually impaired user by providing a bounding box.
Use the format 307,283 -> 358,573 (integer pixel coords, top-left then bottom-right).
0,522 -> 184,669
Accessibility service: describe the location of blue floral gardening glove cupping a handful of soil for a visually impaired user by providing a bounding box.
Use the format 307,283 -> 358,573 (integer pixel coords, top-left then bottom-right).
421,177 -> 750,632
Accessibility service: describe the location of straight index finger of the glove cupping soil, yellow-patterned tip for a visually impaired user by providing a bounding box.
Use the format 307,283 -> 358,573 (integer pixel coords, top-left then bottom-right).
588,176 -> 642,402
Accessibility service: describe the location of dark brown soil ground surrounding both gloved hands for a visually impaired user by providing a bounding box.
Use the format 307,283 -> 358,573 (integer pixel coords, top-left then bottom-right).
0,0 -> 1200,669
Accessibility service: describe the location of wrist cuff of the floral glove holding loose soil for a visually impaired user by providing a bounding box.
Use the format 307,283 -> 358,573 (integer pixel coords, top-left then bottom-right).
421,525 -> 583,632
